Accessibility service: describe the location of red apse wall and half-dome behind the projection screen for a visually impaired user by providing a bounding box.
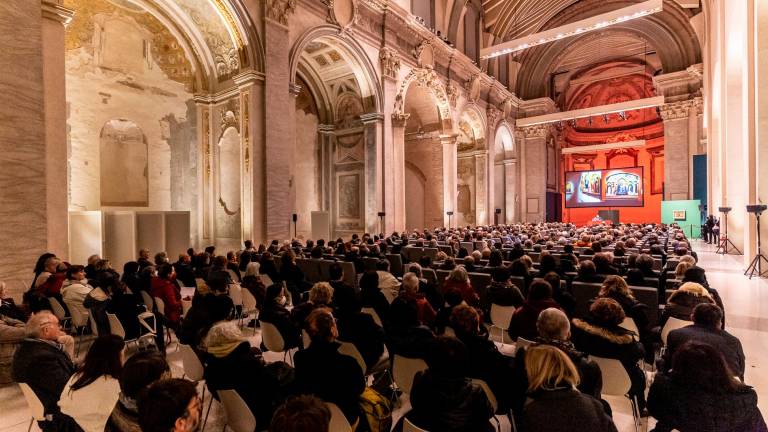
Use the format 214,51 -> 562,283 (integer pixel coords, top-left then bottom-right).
560,61 -> 664,224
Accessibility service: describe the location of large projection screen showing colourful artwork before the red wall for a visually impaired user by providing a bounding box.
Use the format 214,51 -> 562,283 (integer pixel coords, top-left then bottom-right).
565,167 -> 644,208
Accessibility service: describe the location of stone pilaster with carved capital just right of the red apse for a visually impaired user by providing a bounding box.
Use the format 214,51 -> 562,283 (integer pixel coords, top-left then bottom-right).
660,99 -> 693,200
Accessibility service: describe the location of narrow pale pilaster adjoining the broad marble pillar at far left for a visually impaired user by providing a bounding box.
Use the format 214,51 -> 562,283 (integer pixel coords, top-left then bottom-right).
41,0 -> 74,259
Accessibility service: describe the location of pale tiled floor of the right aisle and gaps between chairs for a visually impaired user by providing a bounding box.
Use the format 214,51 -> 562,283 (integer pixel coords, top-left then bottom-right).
0,242 -> 768,432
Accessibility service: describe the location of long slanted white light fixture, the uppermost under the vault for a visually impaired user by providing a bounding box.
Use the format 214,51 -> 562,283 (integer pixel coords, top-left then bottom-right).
480,0 -> 663,59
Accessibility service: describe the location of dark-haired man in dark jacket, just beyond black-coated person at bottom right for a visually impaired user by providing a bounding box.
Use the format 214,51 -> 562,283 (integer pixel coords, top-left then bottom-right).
664,303 -> 744,381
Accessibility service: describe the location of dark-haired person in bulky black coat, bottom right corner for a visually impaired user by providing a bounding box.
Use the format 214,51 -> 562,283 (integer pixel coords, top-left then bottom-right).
648,341 -> 768,432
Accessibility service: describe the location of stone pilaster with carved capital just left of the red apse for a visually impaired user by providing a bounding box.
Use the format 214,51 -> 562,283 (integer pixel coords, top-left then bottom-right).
521,125 -> 549,223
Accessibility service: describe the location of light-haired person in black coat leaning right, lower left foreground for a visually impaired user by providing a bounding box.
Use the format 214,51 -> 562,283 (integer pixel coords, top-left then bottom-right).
204,321 -> 278,425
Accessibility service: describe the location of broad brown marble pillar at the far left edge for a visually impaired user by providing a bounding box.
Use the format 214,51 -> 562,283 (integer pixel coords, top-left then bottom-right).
0,0 -> 48,300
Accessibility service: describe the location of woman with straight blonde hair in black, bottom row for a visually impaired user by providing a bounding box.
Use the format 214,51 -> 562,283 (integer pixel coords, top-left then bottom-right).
518,345 -> 617,432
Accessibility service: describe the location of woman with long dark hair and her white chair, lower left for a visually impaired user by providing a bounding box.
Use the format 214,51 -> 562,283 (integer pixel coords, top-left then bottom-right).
59,335 -> 125,432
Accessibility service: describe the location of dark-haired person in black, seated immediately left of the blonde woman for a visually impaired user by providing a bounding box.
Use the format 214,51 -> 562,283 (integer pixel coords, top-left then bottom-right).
406,336 -> 494,432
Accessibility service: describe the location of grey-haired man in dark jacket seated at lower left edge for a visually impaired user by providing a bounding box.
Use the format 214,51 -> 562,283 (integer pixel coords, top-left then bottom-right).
12,311 -> 77,431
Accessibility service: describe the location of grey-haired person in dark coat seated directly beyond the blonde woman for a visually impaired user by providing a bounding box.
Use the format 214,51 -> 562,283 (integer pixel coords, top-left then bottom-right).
511,308 -> 610,416
